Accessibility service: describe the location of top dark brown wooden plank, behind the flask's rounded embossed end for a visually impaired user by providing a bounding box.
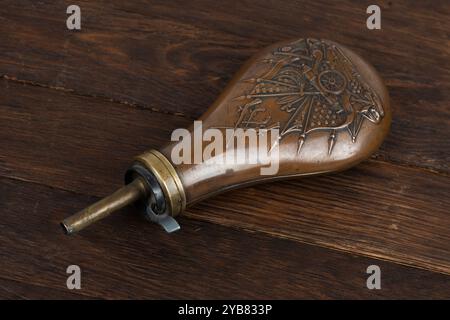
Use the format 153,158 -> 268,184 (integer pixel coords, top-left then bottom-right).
0,0 -> 450,174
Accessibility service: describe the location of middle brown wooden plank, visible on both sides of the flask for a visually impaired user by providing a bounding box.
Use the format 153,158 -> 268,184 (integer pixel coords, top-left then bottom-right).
0,80 -> 450,273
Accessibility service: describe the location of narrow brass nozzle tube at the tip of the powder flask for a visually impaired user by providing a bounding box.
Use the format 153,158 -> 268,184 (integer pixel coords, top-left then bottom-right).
61,178 -> 148,234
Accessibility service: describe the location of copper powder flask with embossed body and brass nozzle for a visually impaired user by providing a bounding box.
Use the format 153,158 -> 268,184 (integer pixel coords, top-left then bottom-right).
62,38 -> 391,234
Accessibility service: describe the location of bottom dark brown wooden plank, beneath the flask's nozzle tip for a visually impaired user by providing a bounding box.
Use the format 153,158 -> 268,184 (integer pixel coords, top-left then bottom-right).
0,178 -> 450,299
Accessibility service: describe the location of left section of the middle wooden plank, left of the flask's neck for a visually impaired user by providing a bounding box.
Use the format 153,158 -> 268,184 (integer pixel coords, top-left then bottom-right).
0,80 -> 189,196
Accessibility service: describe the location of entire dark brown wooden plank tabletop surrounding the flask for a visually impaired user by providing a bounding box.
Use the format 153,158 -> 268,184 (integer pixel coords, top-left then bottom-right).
0,0 -> 450,299
